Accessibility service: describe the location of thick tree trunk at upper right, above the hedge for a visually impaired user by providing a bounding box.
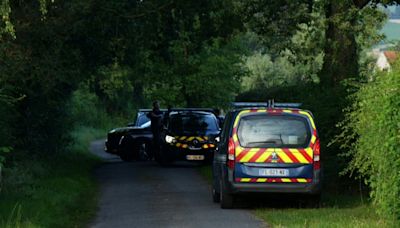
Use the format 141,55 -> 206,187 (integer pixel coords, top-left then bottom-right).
320,0 -> 359,87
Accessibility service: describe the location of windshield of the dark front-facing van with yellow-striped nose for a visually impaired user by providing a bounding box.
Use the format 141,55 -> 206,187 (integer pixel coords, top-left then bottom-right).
169,113 -> 218,134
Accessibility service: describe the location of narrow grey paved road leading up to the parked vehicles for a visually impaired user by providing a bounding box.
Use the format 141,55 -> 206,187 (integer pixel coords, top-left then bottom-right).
91,141 -> 265,228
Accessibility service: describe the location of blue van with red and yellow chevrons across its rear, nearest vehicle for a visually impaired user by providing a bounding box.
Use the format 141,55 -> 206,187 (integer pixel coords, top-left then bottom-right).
212,103 -> 321,208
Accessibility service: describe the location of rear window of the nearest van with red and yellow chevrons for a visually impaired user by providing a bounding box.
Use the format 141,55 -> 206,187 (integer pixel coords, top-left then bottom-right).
238,114 -> 311,148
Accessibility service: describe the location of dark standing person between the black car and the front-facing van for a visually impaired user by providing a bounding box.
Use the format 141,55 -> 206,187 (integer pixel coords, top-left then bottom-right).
147,101 -> 163,155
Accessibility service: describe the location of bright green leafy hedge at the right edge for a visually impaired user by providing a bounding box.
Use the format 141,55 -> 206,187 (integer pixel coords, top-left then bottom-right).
339,64 -> 400,219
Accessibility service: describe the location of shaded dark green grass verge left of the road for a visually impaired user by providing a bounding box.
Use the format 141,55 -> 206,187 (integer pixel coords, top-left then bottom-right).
0,125 -> 104,227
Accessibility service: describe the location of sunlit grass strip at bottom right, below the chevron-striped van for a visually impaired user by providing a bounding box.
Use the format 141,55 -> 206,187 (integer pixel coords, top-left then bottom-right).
199,166 -> 398,228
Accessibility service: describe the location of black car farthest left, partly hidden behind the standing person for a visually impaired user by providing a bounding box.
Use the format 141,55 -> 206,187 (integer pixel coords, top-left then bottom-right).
105,109 -> 166,161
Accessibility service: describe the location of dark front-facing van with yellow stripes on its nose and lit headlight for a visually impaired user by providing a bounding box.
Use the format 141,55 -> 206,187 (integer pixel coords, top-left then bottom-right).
155,109 -> 220,164
